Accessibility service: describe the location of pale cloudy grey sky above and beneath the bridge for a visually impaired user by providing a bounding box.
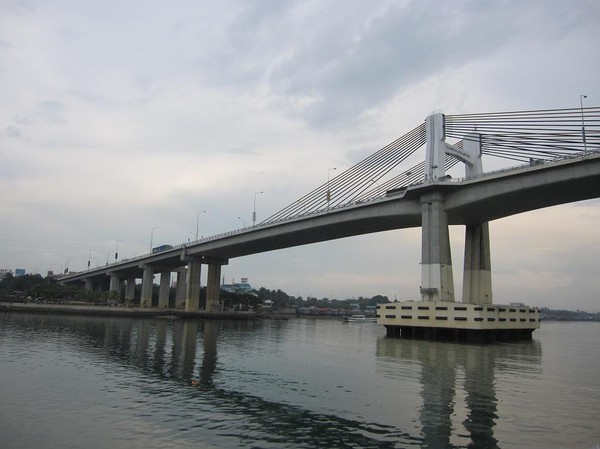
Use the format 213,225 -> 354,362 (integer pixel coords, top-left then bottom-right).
0,0 -> 600,311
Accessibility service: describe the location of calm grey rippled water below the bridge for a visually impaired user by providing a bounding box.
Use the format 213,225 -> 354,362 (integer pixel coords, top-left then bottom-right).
0,313 -> 600,449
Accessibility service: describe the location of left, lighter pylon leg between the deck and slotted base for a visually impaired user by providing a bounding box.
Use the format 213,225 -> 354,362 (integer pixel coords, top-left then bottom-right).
421,193 -> 455,301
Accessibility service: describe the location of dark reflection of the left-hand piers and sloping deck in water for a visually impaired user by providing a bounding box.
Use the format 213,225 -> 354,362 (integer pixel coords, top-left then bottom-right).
7,315 -> 422,448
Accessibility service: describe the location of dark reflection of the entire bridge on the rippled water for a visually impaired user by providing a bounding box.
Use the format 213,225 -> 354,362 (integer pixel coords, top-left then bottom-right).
5,315 -> 541,448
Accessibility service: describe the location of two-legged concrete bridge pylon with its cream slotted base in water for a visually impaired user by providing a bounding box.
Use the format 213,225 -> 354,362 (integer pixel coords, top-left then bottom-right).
377,113 -> 540,341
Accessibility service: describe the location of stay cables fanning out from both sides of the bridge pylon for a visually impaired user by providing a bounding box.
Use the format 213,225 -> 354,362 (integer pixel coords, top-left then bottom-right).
262,107 -> 600,224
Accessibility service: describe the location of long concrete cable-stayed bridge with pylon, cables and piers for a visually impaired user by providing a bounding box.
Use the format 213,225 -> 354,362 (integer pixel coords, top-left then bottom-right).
61,107 -> 600,340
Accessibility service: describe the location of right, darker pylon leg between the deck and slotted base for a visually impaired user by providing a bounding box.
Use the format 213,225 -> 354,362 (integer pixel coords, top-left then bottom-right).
462,222 -> 492,304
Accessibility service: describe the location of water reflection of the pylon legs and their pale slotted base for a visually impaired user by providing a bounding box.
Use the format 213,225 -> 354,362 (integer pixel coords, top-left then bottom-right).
377,338 -> 541,449
